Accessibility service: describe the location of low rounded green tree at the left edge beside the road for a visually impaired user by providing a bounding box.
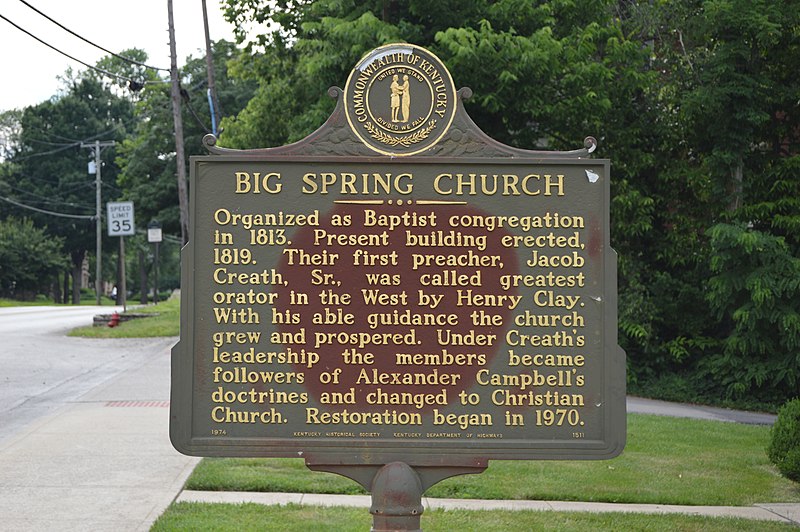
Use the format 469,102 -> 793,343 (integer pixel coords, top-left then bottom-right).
0,218 -> 66,300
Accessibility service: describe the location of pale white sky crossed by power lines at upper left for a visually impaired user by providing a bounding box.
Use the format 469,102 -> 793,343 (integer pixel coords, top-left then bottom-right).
0,0 -> 242,112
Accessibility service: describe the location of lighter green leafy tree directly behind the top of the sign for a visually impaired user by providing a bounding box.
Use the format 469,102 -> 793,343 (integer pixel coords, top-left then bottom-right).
214,0 -> 668,376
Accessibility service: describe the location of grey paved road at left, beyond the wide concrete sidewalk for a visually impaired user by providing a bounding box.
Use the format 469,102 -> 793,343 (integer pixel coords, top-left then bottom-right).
0,306 -> 174,442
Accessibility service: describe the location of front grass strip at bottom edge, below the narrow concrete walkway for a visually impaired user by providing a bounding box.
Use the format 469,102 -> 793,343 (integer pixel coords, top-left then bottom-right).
151,503 -> 796,532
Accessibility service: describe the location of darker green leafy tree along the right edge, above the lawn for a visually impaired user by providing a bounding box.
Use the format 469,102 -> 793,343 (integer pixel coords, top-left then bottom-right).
639,0 -> 800,403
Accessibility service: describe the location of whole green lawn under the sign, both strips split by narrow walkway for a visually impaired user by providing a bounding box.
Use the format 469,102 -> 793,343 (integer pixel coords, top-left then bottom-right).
158,414 -> 800,532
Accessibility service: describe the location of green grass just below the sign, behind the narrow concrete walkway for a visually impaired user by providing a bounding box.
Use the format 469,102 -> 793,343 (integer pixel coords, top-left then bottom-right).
186,414 -> 800,506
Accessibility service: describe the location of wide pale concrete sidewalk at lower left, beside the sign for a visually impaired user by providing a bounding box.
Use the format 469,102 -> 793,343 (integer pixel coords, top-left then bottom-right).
0,338 -> 198,531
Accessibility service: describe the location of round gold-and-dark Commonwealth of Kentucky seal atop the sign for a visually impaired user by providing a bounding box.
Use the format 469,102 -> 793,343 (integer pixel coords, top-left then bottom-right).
344,43 -> 456,156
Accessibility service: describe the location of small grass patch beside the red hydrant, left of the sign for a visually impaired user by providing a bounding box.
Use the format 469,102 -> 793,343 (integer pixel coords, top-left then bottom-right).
69,297 -> 180,338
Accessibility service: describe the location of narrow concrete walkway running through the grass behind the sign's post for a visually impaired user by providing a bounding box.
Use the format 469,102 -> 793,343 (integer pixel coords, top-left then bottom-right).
177,491 -> 800,525
